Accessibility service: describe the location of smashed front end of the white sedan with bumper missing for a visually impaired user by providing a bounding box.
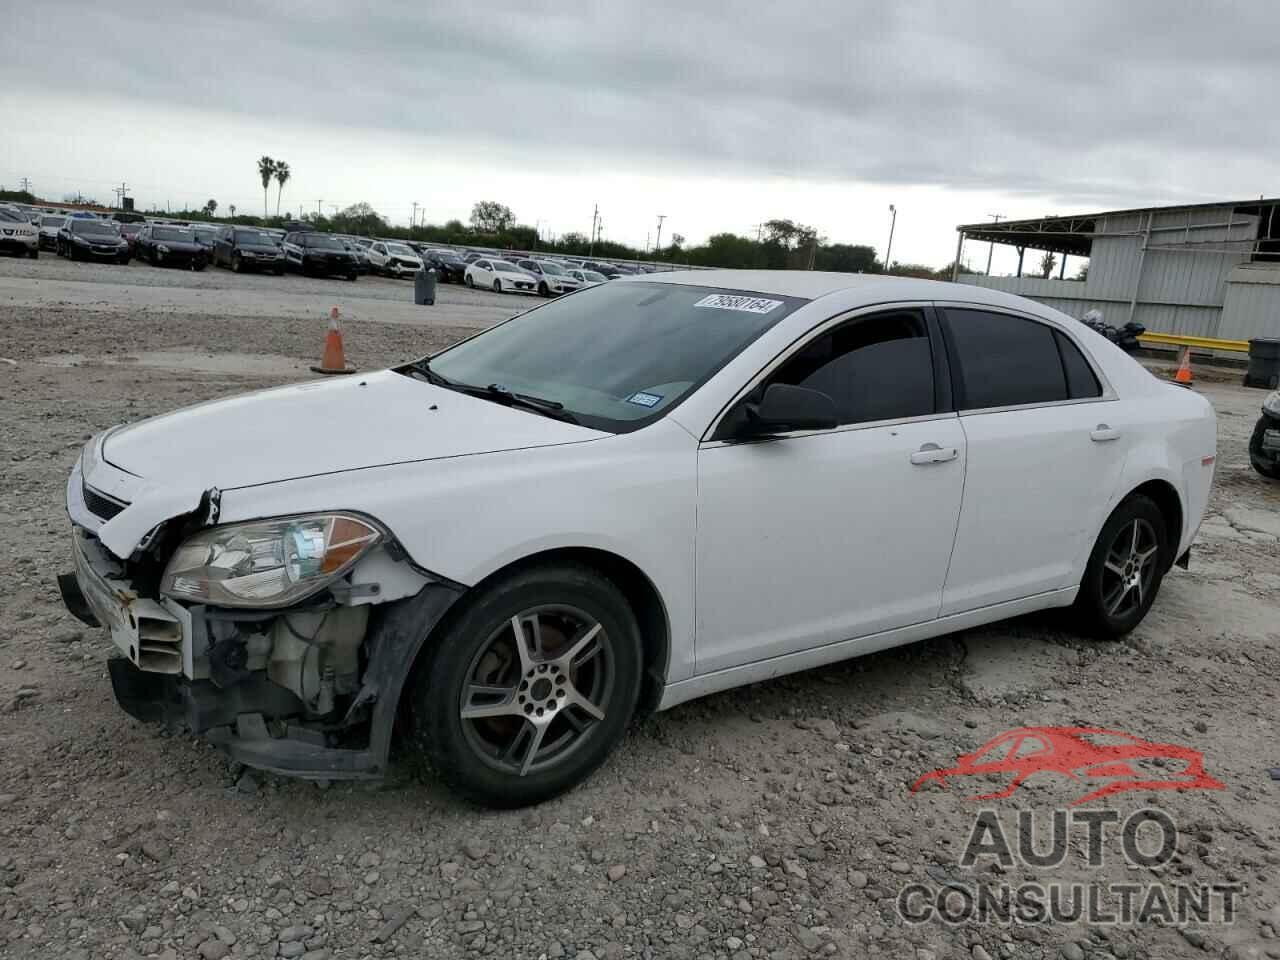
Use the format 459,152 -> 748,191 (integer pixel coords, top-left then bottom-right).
59,442 -> 462,780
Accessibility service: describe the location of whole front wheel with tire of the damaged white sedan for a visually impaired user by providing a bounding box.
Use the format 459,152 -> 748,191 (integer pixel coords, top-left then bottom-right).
410,564 -> 641,808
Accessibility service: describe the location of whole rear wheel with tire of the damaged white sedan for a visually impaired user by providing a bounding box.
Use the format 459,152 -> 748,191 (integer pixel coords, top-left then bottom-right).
1075,494 -> 1170,640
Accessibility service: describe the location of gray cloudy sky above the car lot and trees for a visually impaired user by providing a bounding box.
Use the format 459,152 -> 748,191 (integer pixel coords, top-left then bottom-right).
0,0 -> 1280,270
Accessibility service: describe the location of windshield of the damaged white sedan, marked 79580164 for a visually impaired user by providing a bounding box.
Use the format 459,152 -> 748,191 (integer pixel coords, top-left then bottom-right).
431,282 -> 805,433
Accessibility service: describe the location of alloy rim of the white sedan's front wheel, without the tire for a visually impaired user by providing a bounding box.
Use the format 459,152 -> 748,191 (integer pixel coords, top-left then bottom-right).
458,605 -> 616,777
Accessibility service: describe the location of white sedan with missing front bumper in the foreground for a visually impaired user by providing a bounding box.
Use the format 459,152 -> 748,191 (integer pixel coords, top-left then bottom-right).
60,270 -> 1216,806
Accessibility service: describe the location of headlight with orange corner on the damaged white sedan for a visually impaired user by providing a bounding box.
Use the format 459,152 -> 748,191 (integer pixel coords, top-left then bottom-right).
160,513 -> 383,607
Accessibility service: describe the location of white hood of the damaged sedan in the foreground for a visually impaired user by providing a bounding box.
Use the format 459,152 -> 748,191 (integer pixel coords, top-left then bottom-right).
102,370 -> 607,490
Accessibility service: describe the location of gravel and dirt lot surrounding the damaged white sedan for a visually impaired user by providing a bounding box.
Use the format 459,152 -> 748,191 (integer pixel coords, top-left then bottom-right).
0,257 -> 1280,960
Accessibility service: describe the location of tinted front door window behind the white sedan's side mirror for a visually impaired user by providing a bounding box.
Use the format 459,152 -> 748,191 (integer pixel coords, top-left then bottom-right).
769,310 -> 936,424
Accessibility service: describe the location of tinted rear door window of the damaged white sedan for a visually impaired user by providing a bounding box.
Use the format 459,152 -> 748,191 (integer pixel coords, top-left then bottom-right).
946,308 -> 1069,410
